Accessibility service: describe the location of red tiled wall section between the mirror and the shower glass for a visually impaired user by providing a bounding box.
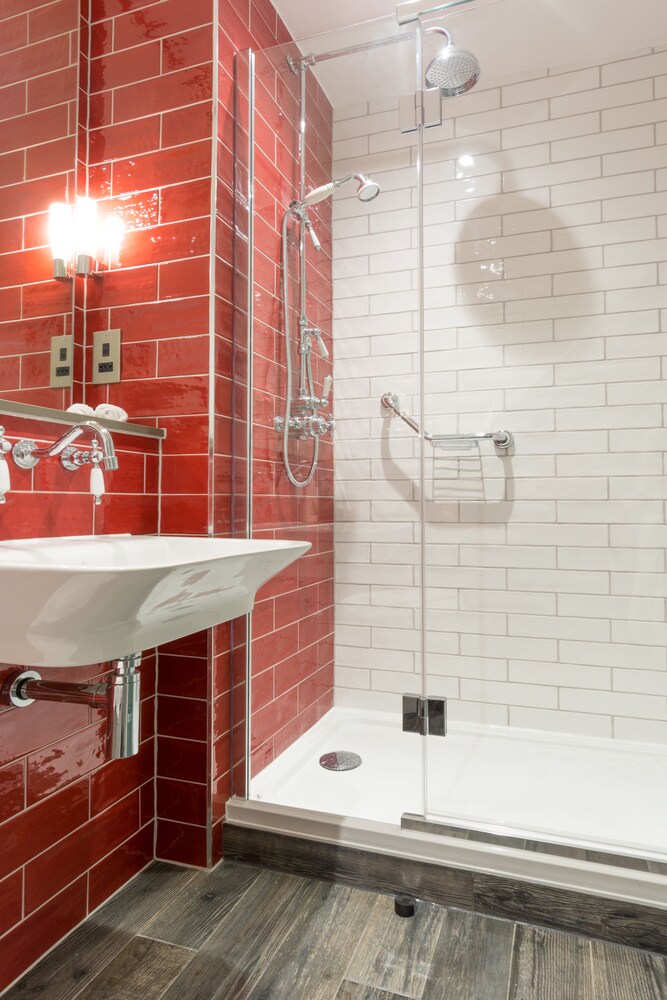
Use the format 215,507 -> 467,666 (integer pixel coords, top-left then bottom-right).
81,0 -> 213,876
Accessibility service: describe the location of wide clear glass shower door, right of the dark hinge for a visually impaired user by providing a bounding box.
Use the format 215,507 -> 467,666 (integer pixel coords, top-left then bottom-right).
419,21 -> 667,871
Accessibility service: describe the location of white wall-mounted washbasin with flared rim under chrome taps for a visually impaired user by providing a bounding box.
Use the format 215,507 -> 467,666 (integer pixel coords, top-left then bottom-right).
0,535 -> 310,667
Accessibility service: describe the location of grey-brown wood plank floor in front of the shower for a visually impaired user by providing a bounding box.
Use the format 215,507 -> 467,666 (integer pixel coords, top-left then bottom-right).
4,861 -> 667,1000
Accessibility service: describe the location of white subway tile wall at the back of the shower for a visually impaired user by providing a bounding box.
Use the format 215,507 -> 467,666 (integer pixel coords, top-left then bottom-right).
333,43 -> 667,743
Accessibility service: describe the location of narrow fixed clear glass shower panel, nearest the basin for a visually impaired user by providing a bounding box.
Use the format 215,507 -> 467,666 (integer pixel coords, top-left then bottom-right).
241,18 -> 434,825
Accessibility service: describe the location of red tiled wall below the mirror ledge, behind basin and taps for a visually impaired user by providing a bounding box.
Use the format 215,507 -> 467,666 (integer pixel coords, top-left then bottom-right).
0,414 -> 159,990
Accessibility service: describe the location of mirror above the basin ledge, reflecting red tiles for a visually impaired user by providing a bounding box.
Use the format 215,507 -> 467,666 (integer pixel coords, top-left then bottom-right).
0,0 -> 79,408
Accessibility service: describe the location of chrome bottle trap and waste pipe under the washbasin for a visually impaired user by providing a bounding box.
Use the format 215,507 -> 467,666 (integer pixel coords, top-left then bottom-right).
0,653 -> 141,760
